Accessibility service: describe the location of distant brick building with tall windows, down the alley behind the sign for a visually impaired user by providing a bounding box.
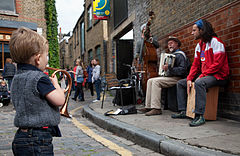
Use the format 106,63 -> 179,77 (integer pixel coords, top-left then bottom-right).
60,0 -> 108,73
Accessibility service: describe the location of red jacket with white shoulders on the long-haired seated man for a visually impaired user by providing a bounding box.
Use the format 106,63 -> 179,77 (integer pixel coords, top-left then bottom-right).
187,37 -> 229,81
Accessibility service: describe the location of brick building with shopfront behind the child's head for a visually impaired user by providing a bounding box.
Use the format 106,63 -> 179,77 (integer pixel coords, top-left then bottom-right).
0,0 -> 46,69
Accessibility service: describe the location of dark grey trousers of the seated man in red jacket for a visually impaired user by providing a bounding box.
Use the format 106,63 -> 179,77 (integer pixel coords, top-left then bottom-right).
177,76 -> 227,115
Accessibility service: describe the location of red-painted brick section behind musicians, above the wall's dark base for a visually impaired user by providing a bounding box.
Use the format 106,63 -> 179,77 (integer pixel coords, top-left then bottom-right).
159,2 -> 240,93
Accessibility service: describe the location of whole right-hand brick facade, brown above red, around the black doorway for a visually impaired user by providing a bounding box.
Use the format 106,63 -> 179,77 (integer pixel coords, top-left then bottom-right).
108,0 -> 240,120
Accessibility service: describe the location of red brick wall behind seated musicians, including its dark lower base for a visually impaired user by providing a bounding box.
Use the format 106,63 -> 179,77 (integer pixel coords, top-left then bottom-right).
153,1 -> 240,121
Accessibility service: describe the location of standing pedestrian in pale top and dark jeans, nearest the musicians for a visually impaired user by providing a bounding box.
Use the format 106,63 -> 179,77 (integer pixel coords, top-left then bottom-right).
92,59 -> 101,102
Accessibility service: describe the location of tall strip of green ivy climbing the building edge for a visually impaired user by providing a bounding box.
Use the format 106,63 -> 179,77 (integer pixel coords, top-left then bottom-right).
45,0 -> 60,74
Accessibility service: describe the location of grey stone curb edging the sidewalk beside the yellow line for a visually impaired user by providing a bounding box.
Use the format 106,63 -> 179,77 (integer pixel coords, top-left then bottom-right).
83,105 -> 234,156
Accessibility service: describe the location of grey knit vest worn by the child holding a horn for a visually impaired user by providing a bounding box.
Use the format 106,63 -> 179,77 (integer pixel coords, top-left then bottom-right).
11,70 -> 60,127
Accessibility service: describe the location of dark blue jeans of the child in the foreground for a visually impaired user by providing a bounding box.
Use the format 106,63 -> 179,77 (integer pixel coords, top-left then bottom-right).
12,129 -> 54,156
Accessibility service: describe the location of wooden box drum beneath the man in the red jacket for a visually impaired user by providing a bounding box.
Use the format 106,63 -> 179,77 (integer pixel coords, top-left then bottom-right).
186,83 -> 219,120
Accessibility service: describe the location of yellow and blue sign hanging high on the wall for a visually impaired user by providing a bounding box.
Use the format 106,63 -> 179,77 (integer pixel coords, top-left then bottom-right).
93,0 -> 110,20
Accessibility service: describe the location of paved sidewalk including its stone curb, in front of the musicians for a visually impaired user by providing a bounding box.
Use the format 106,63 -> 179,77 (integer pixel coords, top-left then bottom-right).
83,94 -> 240,156
